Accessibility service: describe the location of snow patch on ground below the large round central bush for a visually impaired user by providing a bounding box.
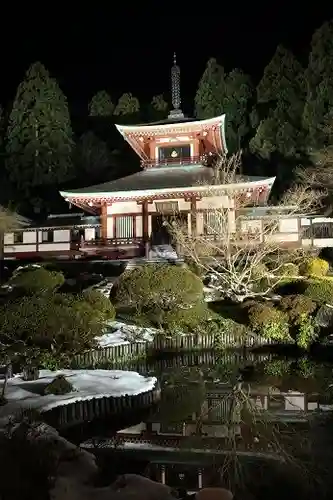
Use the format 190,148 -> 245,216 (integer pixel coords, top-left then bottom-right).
96,321 -> 157,347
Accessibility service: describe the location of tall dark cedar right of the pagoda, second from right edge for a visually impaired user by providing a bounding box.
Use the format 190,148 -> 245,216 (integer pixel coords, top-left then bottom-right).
250,46 -> 306,158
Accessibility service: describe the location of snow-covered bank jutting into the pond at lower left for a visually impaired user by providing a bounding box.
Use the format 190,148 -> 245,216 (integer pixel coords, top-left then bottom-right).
0,370 -> 157,423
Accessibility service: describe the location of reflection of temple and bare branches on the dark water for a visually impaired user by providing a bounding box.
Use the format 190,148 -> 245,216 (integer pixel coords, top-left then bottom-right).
80,353 -> 333,498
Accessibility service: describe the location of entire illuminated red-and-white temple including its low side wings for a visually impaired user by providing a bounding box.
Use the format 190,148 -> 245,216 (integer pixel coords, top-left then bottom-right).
4,59 -> 333,260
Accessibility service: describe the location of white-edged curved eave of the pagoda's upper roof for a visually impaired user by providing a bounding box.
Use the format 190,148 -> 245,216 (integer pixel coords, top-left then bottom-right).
115,114 -> 225,138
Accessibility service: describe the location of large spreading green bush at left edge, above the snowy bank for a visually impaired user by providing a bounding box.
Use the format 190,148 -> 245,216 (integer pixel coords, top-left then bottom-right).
0,294 -> 101,366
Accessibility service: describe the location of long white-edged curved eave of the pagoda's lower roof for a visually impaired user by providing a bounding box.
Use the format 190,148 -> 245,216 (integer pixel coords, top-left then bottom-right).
60,177 -> 275,204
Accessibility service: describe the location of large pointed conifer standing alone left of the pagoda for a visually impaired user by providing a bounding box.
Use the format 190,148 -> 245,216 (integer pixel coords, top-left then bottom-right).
6,62 -> 73,189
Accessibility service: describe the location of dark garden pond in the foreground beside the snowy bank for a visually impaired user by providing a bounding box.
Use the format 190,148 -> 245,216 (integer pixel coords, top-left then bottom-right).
66,351 -> 333,498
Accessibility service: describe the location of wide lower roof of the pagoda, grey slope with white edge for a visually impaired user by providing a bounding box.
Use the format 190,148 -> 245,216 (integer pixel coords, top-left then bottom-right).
61,165 -> 275,198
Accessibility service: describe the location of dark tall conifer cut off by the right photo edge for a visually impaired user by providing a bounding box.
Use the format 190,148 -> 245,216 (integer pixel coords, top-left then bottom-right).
303,20 -> 333,150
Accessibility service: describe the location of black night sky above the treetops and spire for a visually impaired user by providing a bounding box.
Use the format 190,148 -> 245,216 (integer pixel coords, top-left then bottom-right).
0,4 -> 333,115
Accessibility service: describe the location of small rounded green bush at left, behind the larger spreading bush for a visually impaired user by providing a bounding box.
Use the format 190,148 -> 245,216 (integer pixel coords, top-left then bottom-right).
9,267 -> 65,295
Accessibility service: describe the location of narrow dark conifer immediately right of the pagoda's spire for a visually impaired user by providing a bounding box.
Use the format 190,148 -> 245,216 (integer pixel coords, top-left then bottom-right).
195,58 -> 225,120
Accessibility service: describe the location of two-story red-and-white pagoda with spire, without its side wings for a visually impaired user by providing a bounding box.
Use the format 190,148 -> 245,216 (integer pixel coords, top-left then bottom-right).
61,55 -> 274,257
